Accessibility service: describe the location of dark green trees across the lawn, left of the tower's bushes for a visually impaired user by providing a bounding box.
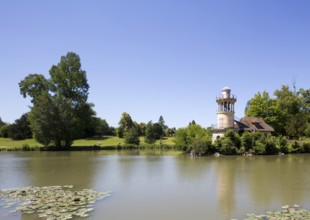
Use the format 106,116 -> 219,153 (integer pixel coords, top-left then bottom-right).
0,52 -> 175,148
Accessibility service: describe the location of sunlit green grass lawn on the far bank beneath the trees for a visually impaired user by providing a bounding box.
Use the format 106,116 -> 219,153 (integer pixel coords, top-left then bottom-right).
0,136 -> 174,150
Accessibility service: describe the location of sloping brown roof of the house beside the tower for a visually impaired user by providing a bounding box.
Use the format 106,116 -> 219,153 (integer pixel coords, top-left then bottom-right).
235,117 -> 274,132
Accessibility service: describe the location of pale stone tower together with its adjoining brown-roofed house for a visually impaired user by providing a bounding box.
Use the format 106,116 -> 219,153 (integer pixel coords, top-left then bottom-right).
212,87 -> 274,141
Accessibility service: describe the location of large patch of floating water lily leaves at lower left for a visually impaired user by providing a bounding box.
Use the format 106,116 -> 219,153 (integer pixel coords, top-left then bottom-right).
0,185 -> 110,220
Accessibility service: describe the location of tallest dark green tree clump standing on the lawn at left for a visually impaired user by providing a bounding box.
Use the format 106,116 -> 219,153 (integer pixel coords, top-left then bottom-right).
19,52 -> 95,147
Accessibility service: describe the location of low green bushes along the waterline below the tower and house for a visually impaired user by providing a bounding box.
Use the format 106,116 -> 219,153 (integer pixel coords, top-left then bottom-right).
175,124 -> 310,156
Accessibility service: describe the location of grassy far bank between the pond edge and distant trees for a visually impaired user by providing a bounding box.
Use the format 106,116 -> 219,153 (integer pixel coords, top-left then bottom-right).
0,136 -> 174,151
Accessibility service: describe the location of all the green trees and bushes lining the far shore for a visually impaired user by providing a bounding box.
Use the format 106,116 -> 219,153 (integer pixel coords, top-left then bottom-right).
0,52 -> 310,154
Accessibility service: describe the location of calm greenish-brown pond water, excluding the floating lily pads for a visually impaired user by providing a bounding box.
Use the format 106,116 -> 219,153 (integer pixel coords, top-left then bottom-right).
0,151 -> 310,220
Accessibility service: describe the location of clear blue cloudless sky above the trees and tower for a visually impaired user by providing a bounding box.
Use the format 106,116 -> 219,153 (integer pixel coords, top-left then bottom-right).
0,0 -> 310,128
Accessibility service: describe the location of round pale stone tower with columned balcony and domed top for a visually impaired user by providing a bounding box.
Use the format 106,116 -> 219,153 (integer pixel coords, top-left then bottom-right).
216,87 -> 237,129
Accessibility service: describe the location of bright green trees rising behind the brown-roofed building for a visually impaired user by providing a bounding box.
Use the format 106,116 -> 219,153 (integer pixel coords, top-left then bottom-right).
245,85 -> 310,139
